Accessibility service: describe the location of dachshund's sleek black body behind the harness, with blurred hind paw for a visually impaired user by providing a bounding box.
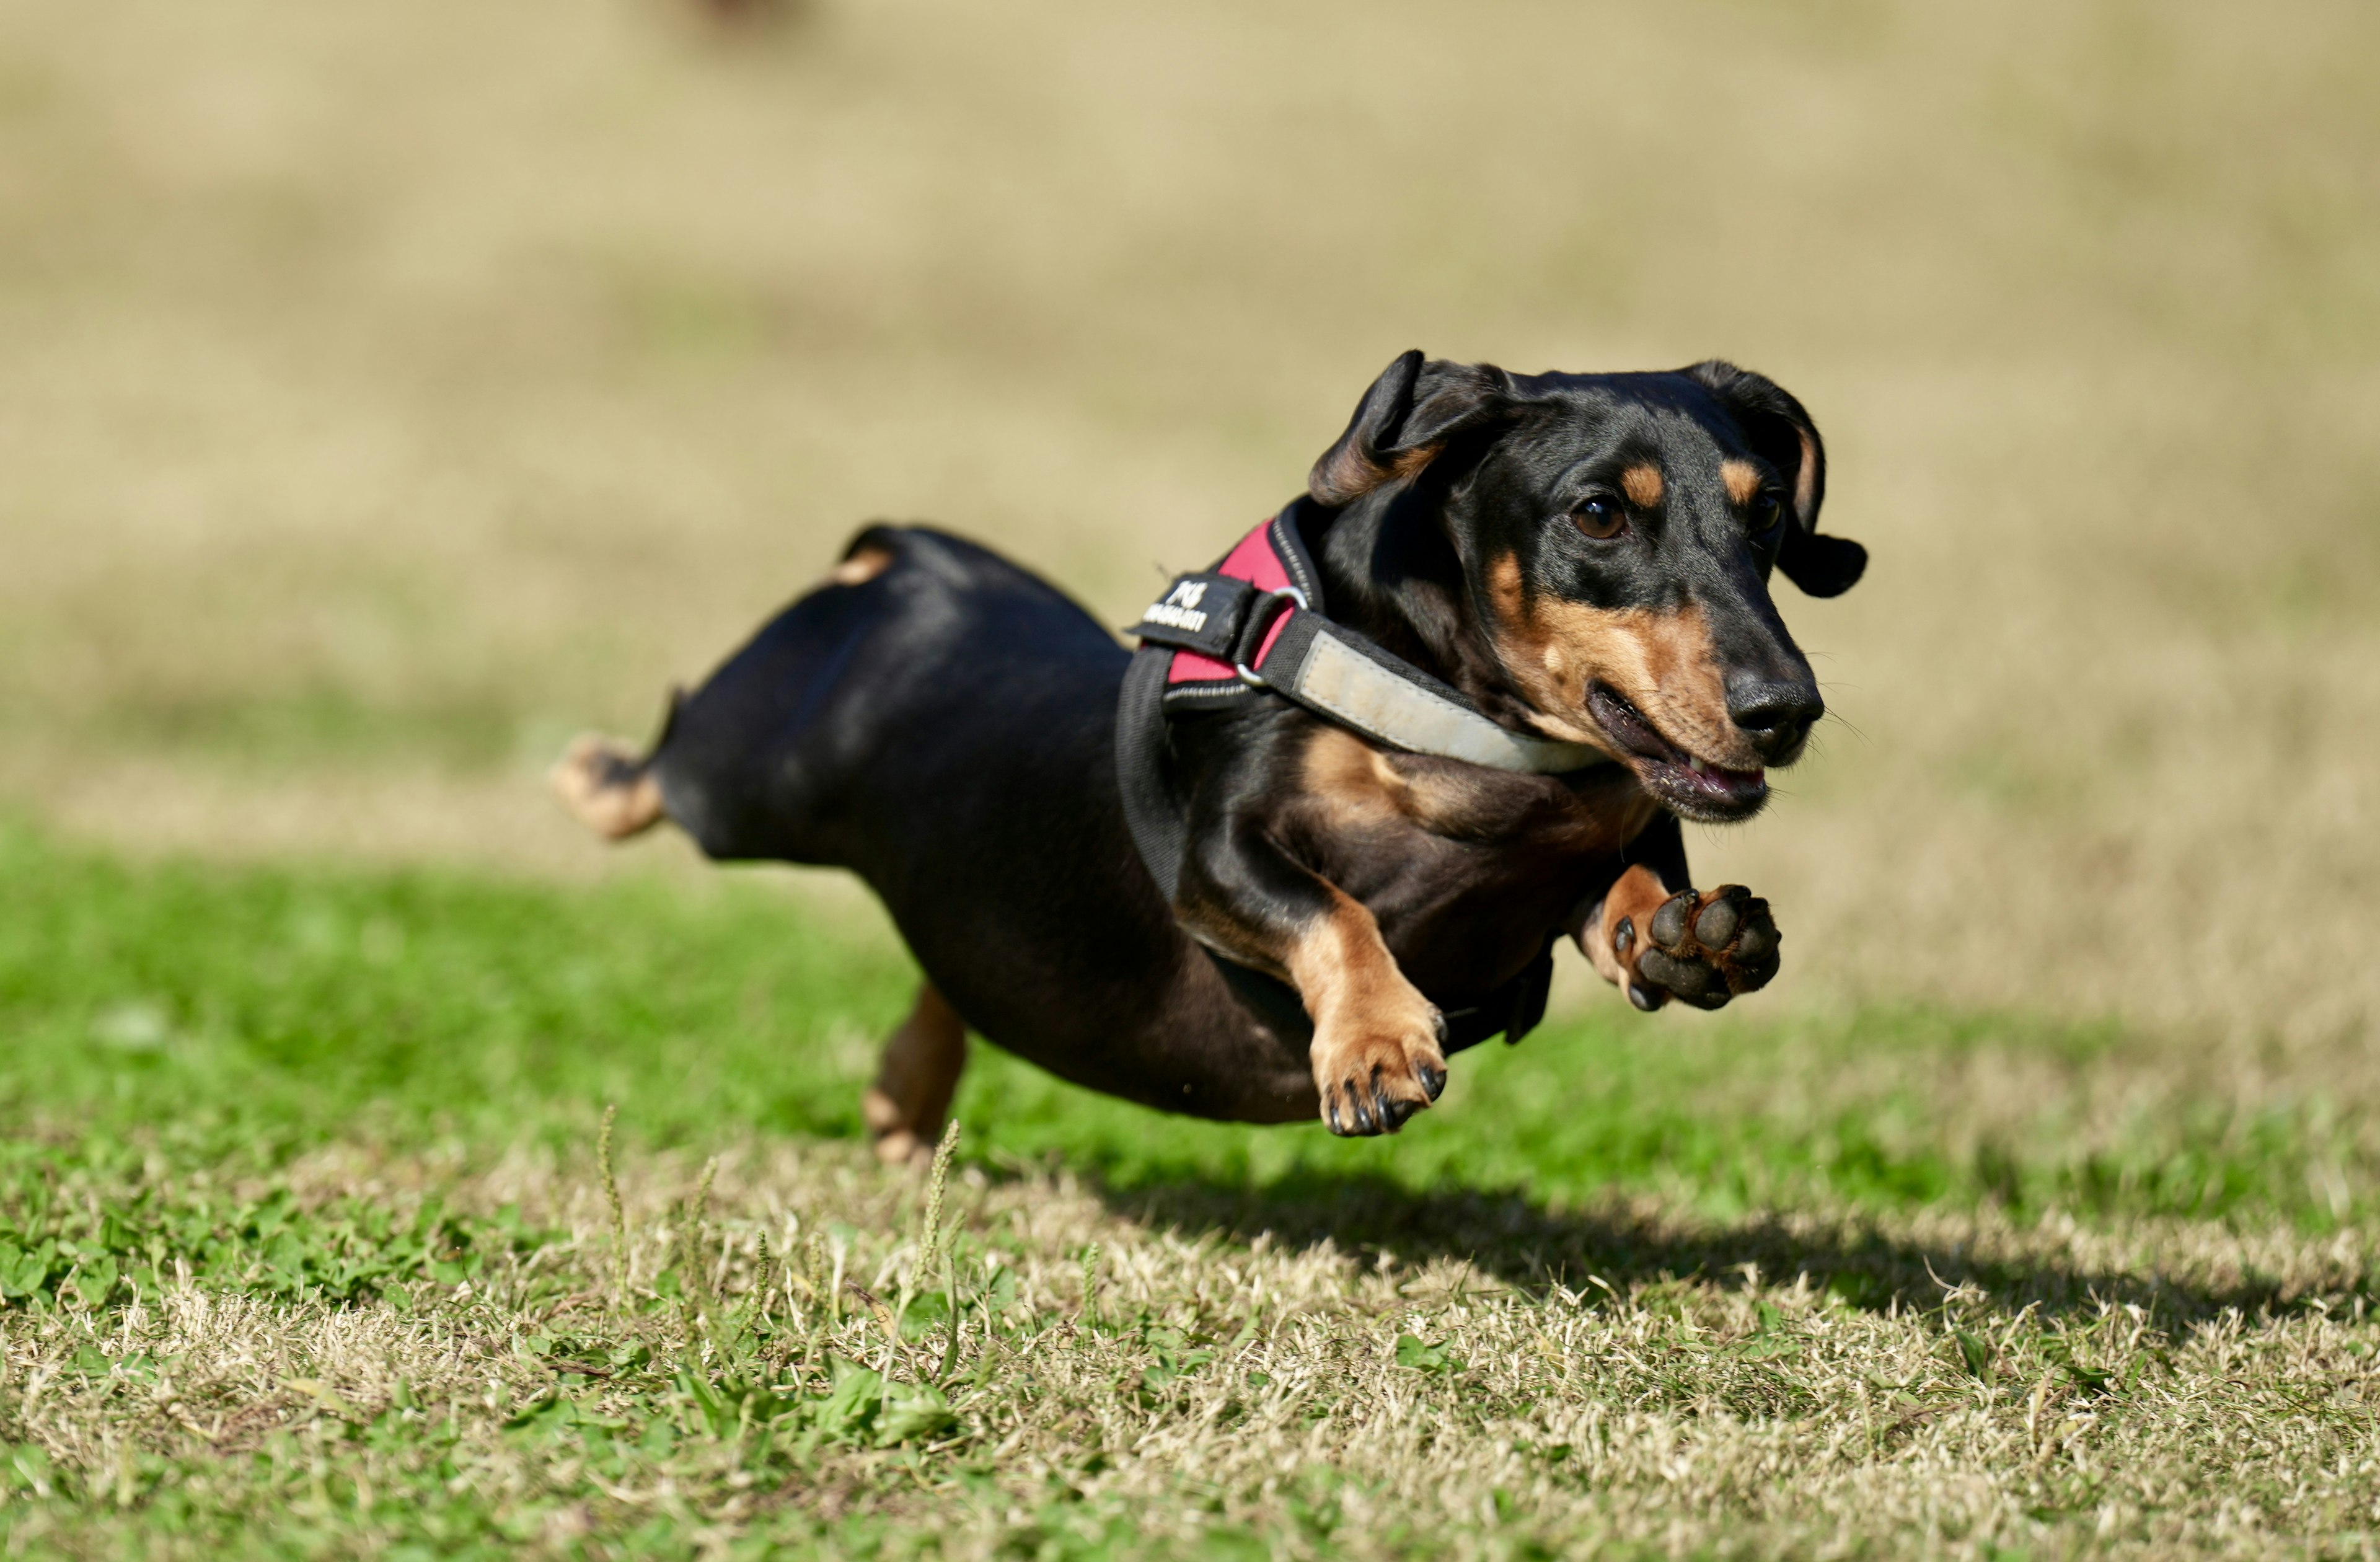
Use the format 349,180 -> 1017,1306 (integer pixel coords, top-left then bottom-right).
557,526 -> 1311,1124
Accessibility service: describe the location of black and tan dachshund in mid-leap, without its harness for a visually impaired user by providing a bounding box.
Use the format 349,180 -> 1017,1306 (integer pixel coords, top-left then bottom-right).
555,353 -> 1866,1160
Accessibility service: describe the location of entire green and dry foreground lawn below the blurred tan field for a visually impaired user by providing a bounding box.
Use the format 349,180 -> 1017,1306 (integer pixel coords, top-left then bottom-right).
0,831 -> 2380,1557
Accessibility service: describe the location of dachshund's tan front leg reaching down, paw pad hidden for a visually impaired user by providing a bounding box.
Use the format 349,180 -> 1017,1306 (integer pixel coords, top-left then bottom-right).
1176,819 -> 1447,1134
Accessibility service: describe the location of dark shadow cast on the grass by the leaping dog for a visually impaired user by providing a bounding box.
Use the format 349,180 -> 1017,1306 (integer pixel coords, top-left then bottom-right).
1093,1174 -> 2375,1326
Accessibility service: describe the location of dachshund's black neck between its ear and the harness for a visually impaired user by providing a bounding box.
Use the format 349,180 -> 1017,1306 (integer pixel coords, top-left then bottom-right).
1307,483 -> 1528,726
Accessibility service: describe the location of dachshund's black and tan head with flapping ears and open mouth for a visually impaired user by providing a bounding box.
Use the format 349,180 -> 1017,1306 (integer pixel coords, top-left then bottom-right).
1309,353 -> 1868,821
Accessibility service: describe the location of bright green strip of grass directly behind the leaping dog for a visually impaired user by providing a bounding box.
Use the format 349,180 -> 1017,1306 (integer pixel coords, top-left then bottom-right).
0,834 -> 2363,1229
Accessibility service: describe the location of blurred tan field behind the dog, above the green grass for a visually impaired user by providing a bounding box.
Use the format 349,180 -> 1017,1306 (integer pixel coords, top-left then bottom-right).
0,0 -> 2380,1048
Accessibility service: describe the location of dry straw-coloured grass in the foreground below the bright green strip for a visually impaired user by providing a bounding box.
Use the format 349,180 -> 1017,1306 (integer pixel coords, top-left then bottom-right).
14,1145 -> 2380,1557
